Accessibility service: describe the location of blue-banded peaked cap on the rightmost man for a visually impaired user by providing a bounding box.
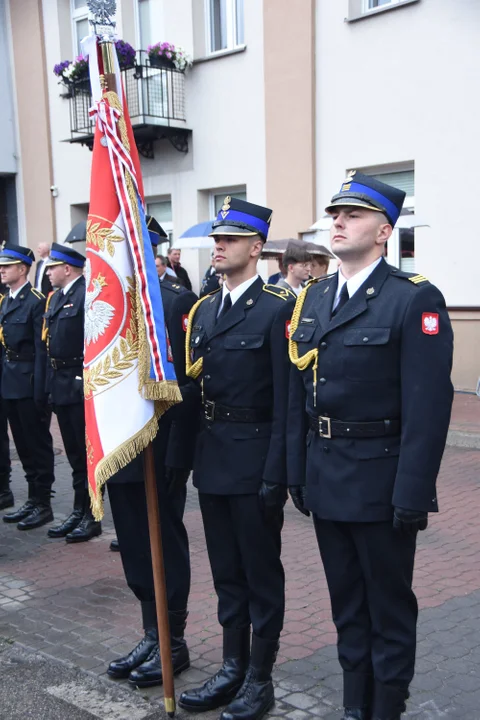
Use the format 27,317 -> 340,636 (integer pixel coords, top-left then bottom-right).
325,170 -> 405,227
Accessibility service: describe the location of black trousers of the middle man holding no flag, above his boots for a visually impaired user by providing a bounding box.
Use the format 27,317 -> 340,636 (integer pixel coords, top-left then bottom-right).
199,493 -> 285,640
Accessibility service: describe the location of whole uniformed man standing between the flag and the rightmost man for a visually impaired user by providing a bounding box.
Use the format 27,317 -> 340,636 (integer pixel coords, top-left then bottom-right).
180,196 -> 295,720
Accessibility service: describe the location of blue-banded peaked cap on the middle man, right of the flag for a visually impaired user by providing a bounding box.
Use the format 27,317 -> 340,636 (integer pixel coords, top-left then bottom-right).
209,195 -> 272,242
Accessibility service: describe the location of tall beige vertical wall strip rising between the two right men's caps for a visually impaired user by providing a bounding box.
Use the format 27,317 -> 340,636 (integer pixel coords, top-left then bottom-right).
263,0 -> 316,239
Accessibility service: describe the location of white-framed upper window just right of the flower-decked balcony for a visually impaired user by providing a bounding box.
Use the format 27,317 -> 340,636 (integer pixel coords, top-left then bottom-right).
206,0 -> 245,53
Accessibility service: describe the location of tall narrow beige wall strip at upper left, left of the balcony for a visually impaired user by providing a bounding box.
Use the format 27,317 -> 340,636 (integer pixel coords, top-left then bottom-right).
10,0 -> 55,248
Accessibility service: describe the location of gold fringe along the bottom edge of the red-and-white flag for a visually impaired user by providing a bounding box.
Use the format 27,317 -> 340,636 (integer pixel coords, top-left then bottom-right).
87,412 -> 161,522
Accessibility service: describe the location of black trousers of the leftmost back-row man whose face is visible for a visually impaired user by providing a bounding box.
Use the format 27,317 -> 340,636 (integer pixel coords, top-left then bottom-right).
4,398 -> 55,491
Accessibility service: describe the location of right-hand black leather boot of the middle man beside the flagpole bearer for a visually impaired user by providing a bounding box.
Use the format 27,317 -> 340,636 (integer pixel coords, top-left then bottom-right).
220,667 -> 275,720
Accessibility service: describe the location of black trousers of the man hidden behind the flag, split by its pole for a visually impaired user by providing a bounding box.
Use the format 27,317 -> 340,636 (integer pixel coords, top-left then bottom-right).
107,478 -> 190,612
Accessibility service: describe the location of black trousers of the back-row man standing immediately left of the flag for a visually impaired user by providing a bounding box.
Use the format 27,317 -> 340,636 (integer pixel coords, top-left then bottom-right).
54,402 -> 87,492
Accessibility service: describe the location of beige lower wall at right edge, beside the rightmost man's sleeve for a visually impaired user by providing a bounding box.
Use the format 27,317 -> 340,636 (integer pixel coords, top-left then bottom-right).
450,309 -> 480,390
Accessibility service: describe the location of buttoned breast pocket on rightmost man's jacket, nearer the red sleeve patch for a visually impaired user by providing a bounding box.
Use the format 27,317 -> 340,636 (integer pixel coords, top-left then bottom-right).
344,327 -> 398,382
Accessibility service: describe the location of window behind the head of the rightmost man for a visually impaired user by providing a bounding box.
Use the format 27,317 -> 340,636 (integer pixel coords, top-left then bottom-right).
367,170 -> 415,272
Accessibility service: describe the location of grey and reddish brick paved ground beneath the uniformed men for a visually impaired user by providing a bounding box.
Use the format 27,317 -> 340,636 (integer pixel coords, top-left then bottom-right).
0,396 -> 480,720
